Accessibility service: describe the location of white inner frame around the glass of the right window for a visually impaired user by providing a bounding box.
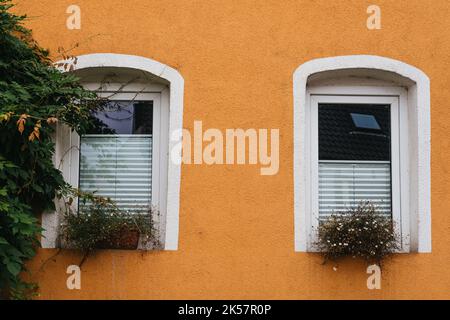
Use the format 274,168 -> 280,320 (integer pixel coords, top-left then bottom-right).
306,90 -> 410,252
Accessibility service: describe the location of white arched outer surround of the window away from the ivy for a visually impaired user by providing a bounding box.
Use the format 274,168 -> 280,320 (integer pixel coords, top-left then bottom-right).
293,55 -> 431,252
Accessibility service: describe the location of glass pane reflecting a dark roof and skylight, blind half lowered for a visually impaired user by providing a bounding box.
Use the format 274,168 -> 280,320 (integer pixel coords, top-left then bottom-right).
319,104 -> 391,220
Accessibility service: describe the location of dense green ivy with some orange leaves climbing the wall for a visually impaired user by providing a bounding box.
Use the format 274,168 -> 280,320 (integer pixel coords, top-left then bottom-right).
0,0 -> 102,299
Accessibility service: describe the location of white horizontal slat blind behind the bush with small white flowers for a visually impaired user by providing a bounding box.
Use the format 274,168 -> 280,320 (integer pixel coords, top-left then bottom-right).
319,161 -> 391,220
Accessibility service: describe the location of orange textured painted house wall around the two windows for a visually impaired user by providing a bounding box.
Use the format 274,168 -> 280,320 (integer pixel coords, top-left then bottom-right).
16,0 -> 450,299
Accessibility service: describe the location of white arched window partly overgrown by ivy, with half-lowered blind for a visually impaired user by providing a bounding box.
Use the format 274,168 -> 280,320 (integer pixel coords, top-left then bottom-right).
42,54 -> 184,250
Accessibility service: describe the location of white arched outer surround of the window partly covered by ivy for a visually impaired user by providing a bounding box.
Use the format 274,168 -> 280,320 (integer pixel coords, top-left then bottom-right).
41,53 -> 184,250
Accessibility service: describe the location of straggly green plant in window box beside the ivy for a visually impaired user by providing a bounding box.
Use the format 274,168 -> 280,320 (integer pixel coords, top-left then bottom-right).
61,192 -> 159,254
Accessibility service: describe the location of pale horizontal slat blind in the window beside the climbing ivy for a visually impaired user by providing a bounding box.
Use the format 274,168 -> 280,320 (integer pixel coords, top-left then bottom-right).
80,134 -> 152,213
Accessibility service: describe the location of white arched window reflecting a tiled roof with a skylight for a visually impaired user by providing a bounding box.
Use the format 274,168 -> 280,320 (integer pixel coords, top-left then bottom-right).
294,55 -> 431,252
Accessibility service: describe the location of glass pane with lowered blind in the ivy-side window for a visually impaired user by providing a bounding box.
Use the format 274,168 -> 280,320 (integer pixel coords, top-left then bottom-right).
79,101 -> 153,213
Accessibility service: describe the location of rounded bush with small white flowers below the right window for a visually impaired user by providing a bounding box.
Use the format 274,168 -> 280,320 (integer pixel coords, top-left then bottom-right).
315,202 -> 401,264
